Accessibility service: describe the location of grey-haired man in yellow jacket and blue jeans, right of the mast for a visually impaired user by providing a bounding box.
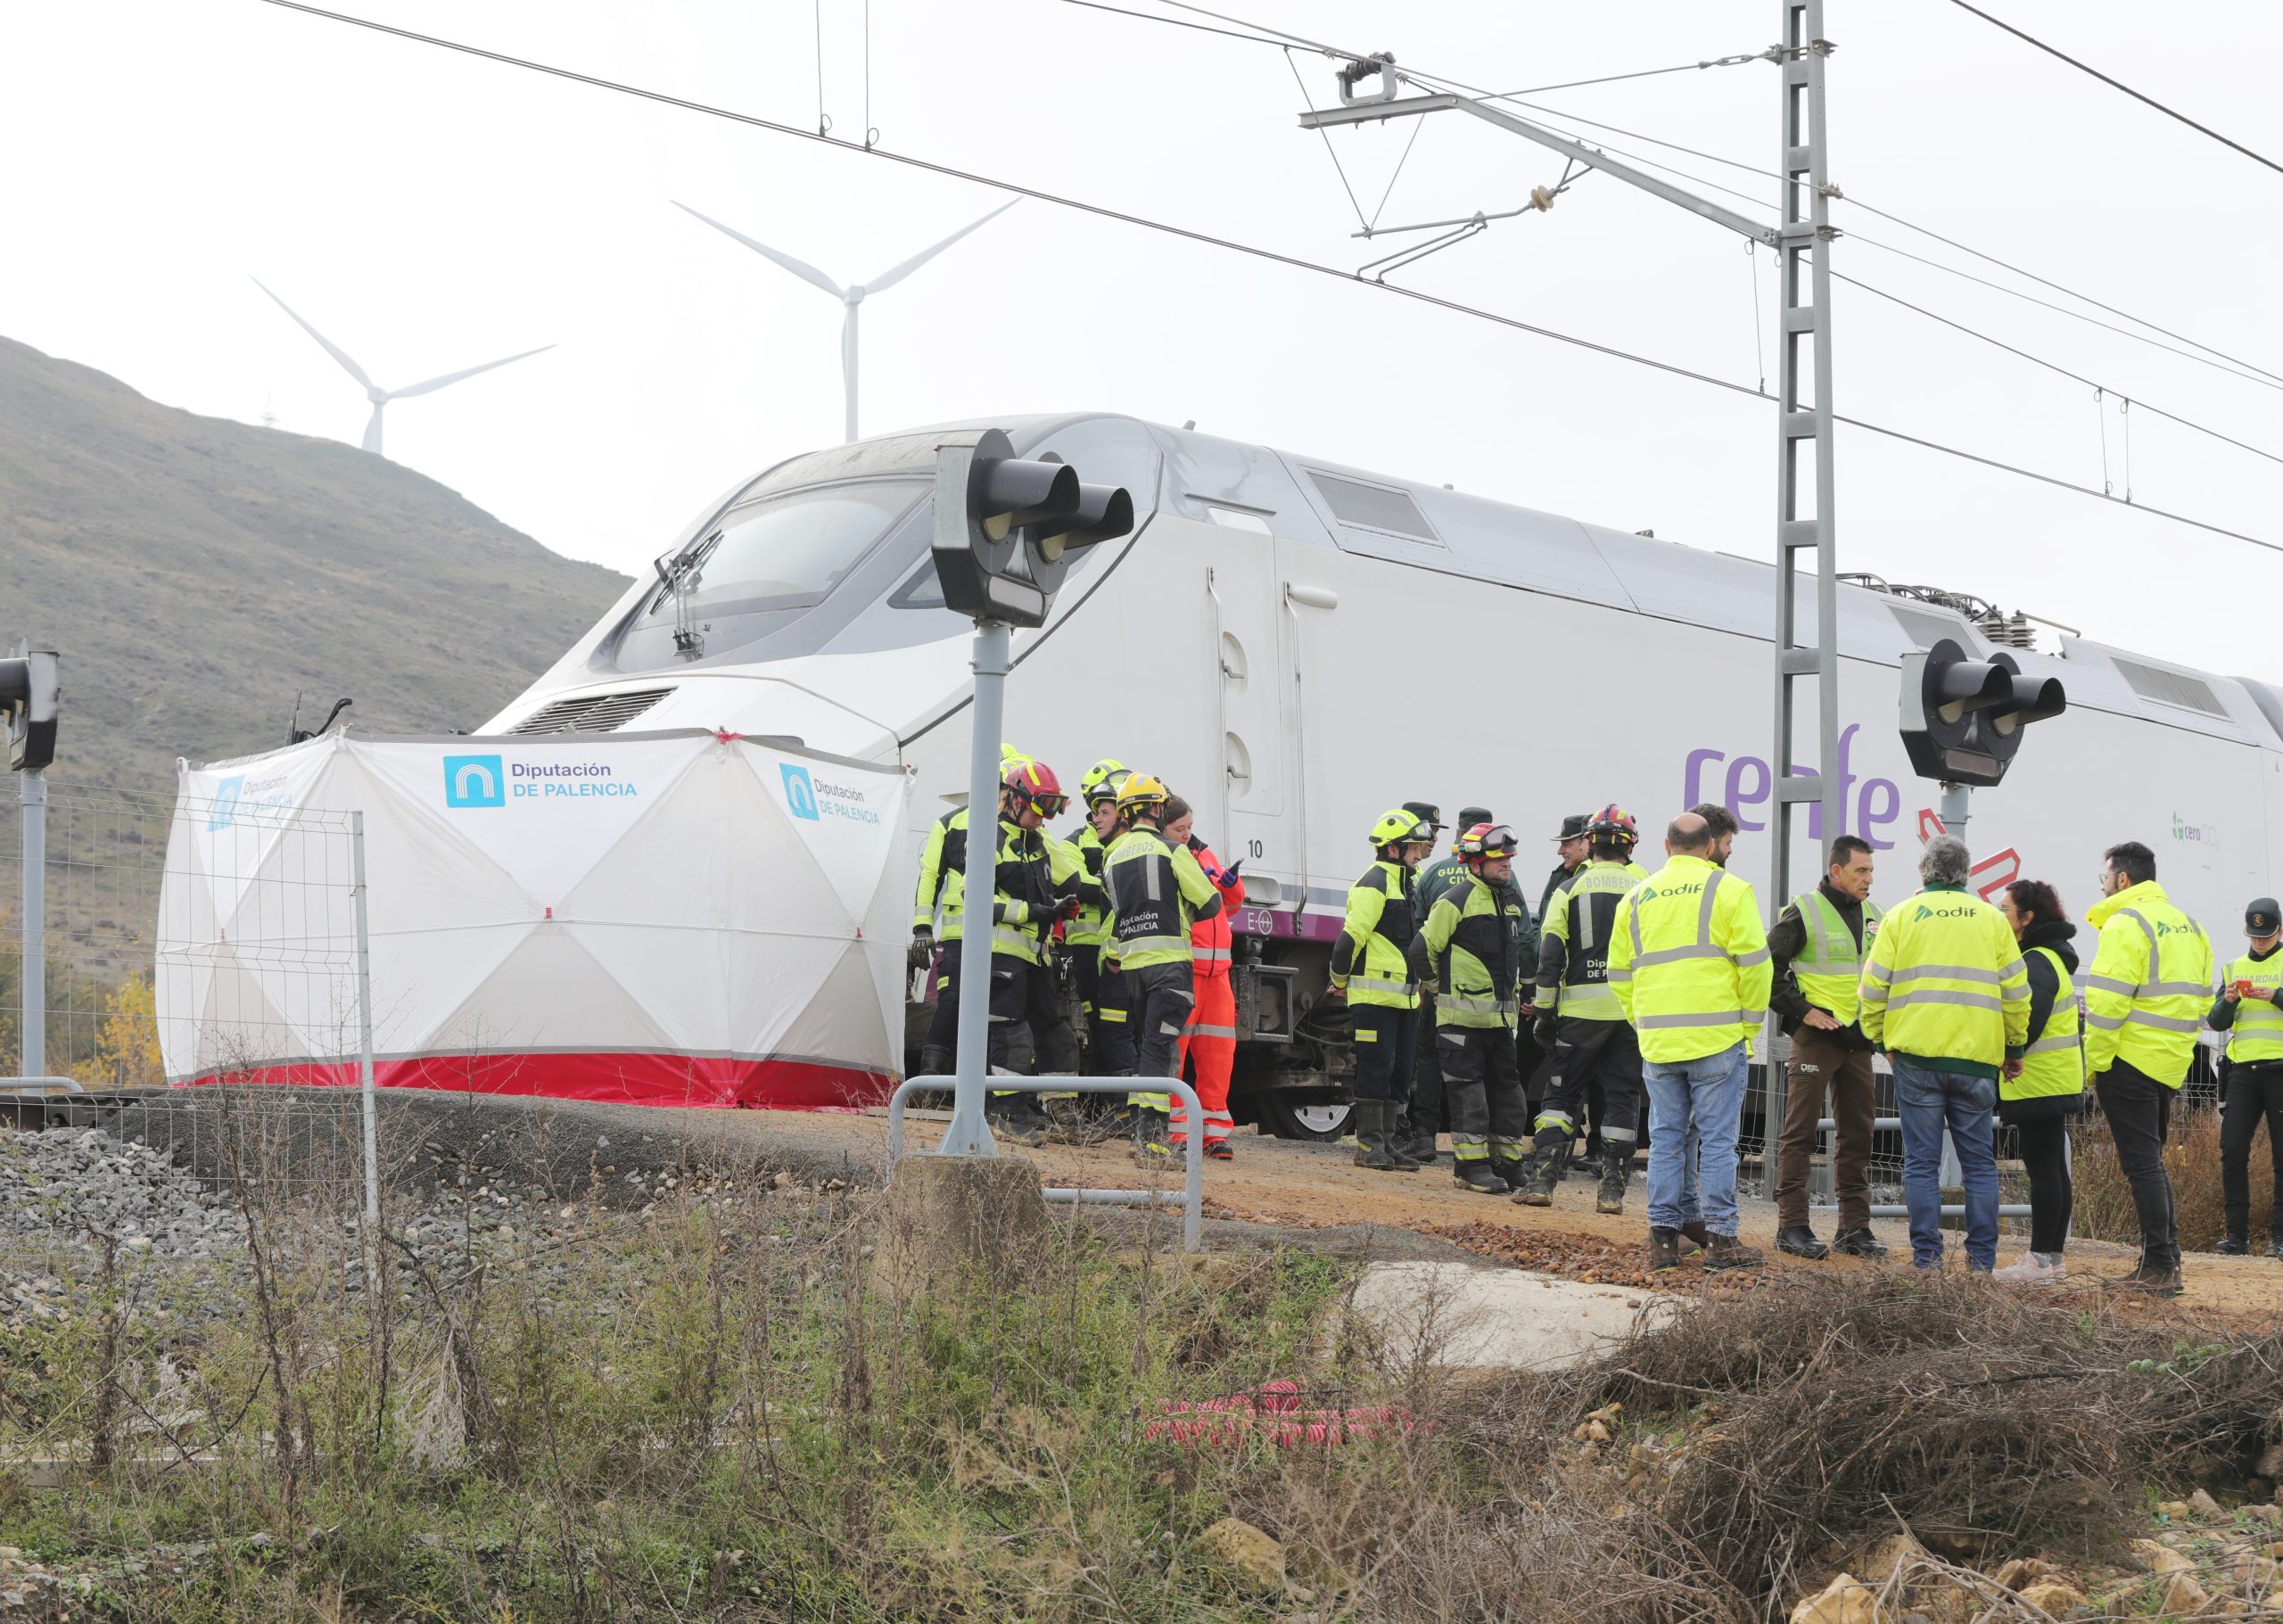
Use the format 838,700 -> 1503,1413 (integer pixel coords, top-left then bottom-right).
1860,834 -> 2030,1274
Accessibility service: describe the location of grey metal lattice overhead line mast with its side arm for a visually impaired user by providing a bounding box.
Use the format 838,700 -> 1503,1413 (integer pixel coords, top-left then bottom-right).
1301,0 -> 1844,1169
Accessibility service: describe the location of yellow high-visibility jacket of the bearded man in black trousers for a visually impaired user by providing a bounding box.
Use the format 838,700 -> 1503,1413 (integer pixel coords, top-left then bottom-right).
2084,879 -> 2213,1087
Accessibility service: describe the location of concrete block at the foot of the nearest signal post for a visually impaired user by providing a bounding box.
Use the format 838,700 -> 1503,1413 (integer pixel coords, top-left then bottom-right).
874,1156 -> 1045,1290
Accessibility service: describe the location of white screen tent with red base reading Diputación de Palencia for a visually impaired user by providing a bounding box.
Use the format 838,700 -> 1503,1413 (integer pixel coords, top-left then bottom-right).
158,731 -> 909,1106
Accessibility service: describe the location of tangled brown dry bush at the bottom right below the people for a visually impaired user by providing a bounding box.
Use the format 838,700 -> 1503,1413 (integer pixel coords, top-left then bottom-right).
1479,1270 -> 2283,1596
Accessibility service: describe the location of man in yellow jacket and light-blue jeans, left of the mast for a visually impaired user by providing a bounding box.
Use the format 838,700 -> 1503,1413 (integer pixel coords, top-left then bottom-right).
1610,811 -> 1772,1270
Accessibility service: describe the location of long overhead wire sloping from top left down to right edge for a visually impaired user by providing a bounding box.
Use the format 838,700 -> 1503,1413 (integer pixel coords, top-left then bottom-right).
258,0 -> 2283,553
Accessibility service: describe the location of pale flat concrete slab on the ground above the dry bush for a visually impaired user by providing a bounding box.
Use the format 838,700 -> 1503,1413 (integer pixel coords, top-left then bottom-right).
1356,1263 -> 1676,1371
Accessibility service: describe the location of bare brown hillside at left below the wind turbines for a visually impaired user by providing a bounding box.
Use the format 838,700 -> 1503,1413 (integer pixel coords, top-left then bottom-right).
0,338 -> 625,799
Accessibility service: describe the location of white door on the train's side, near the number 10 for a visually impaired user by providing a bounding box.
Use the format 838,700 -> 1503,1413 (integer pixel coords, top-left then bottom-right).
1201,523 -> 1297,907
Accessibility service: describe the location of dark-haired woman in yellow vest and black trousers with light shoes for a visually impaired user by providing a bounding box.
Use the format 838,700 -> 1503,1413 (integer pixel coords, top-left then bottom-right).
1990,879 -> 2084,1286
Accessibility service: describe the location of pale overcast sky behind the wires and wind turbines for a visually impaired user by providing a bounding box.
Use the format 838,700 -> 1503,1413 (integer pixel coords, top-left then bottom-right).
0,0 -> 2283,671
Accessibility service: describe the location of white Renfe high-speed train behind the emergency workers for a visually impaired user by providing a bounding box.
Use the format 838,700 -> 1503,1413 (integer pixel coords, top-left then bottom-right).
484,414 -> 2283,1133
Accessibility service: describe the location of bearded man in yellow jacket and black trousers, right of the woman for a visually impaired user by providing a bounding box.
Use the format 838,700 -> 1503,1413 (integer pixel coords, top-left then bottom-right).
2084,841 -> 2213,1298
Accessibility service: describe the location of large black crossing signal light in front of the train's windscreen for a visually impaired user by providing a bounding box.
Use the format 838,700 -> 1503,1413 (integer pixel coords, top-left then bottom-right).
934,430 -> 1134,626
